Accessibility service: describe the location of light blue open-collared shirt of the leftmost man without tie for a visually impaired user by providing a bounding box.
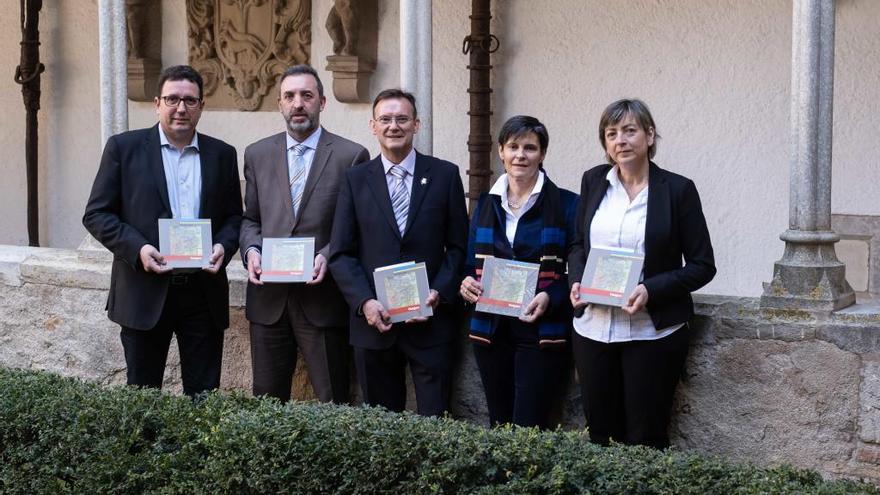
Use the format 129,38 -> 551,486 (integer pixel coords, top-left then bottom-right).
159,125 -> 202,218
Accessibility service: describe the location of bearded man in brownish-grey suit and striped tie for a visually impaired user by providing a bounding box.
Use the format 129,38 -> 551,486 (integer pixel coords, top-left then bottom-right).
240,65 -> 370,403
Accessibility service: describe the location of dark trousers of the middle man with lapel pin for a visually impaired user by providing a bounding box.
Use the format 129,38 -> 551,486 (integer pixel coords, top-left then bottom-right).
354,338 -> 453,416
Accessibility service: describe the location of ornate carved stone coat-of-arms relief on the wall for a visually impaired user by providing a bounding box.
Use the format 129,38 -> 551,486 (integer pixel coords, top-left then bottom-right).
186,0 -> 312,111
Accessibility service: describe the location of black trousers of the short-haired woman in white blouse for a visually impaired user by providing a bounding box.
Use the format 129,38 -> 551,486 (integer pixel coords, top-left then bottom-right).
572,325 -> 690,449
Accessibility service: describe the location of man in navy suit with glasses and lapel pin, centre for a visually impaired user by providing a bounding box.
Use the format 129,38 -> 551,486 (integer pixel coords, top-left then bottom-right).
330,90 -> 467,415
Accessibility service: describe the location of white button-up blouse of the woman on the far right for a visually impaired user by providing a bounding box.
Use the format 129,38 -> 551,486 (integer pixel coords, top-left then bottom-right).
574,165 -> 684,343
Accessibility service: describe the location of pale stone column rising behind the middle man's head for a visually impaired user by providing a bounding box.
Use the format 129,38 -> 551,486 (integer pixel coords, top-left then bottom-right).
400,0 -> 434,154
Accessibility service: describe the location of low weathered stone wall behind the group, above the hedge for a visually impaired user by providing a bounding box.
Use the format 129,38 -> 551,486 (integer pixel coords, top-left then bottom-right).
0,246 -> 880,482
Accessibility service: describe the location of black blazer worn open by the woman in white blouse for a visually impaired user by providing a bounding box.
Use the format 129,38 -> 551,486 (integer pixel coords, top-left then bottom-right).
568,162 -> 715,329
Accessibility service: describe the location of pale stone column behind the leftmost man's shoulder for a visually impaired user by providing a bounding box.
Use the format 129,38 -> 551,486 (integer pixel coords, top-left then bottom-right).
98,0 -> 128,148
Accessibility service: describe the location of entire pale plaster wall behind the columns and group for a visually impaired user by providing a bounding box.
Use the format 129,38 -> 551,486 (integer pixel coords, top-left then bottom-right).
0,0 -> 880,295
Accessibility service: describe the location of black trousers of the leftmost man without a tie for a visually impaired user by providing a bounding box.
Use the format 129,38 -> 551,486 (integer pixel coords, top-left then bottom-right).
120,276 -> 223,397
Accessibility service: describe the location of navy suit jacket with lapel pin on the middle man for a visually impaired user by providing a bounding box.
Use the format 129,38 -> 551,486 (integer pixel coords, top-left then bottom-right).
330,153 -> 468,349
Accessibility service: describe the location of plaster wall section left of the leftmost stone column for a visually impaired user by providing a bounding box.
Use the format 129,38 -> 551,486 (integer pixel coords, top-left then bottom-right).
0,0 -> 101,247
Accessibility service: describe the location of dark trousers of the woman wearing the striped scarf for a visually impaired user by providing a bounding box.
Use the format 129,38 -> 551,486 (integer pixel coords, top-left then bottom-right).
474,317 -> 569,428
